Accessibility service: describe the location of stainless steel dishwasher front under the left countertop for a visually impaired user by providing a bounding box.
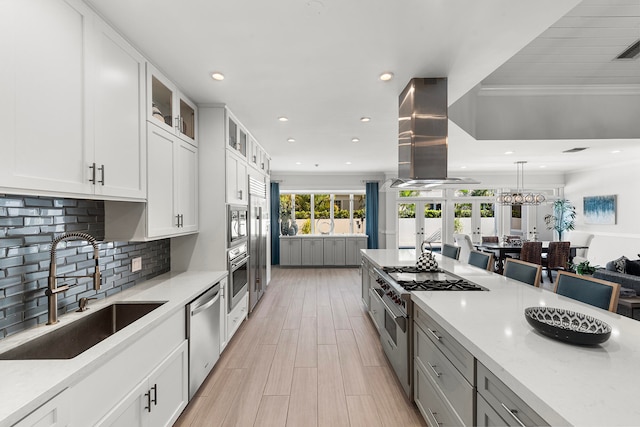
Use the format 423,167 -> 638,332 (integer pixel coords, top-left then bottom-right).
187,283 -> 220,400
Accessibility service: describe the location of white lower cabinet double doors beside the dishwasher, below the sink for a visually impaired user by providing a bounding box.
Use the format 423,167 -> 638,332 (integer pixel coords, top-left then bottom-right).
98,340 -> 189,427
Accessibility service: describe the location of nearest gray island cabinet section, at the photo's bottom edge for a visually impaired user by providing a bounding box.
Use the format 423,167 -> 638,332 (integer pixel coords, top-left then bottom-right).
476,362 -> 549,426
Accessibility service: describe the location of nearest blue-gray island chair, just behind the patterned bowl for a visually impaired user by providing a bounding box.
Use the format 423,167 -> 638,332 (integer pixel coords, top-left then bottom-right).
554,271 -> 620,313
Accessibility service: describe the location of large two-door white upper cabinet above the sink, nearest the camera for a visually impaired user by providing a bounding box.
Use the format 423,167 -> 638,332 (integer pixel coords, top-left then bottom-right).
0,0 -> 145,200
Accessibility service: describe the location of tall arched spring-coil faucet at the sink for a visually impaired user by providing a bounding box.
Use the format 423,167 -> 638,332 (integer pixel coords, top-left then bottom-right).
44,232 -> 100,325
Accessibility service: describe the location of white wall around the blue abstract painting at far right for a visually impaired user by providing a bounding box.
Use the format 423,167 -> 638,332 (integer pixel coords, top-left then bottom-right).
565,160 -> 640,266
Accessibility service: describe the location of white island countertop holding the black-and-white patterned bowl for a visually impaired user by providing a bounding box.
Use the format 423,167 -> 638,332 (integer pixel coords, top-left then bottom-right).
362,249 -> 640,426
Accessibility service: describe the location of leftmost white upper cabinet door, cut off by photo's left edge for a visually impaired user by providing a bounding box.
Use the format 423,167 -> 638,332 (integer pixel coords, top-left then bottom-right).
0,0 -> 93,194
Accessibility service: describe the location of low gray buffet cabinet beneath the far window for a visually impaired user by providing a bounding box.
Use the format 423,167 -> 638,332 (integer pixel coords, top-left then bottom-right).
280,234 -> 367,267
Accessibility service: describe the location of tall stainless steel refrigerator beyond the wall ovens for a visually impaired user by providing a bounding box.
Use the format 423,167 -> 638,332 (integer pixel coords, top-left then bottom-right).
248,177 -> 269,312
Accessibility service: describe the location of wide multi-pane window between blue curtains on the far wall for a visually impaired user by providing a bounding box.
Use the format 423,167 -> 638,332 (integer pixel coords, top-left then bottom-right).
280,193 -> 366,235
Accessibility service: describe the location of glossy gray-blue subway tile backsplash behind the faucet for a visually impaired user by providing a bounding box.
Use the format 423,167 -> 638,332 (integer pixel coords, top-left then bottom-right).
0,194 -> 171,339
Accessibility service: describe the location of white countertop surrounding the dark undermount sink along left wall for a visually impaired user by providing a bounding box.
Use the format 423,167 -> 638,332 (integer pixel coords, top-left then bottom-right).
0,271 -> 227,427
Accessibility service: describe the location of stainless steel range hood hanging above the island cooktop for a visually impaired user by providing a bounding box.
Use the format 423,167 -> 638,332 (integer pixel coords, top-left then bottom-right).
391,77 -> 479,189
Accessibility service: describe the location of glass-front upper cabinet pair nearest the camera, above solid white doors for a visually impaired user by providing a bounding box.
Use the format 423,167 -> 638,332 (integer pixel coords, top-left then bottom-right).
147,64 -> 198,146
